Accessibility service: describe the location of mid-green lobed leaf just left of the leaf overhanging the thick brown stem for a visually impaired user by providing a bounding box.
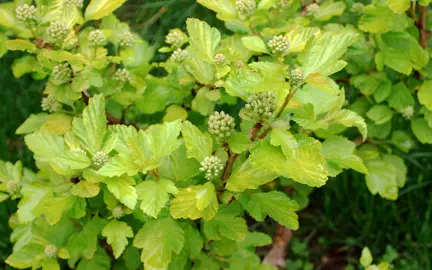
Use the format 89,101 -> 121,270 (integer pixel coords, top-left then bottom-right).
202,206 -> 247,241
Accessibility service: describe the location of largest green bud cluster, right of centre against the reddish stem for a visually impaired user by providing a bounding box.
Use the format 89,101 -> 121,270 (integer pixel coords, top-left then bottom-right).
245,91 -> 277,120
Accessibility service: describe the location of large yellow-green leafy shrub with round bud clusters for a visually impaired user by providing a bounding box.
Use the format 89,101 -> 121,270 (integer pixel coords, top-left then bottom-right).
0,0 -> 432,269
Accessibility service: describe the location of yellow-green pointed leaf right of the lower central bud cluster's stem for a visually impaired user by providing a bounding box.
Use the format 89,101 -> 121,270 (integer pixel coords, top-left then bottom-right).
225,159 -> 278,192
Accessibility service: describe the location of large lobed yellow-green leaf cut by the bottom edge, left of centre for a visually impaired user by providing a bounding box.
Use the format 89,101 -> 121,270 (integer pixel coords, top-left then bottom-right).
133,217 -> 185,269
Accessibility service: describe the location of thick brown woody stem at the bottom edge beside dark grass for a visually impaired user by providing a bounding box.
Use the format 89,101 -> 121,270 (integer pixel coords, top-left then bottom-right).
263,224 -> 292,268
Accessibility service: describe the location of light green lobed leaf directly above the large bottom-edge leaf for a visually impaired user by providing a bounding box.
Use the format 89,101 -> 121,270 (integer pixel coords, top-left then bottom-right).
135,180 -> 178,218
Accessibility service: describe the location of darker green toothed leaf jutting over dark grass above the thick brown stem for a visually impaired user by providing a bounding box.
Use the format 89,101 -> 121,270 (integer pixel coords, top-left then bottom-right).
243,191 -> 299,230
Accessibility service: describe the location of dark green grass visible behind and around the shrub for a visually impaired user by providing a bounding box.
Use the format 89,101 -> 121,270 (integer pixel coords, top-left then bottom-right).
0,0 -> 432,270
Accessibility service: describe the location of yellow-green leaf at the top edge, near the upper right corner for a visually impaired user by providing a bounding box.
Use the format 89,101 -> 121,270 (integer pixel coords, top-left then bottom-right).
358,3 -> 409,34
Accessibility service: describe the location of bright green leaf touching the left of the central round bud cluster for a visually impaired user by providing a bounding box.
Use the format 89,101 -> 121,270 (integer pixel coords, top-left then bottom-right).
181,121 -> 213,162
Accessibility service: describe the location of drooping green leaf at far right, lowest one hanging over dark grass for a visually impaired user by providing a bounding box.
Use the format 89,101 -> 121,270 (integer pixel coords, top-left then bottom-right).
365,159 -> 398,200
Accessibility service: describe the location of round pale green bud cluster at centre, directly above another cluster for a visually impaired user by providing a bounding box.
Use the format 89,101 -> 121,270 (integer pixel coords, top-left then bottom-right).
208,111 -> 235,141
